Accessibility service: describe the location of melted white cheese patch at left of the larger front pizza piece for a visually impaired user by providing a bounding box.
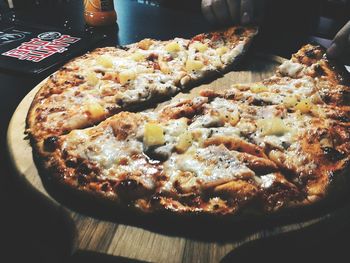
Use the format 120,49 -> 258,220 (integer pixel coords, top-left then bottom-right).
62,126 -> 158,189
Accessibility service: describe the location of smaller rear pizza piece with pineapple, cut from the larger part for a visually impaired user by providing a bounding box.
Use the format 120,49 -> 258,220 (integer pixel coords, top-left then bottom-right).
27,27 -> 257,157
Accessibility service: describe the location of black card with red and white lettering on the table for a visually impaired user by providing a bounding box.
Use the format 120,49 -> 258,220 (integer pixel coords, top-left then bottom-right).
0,25 -> 103,74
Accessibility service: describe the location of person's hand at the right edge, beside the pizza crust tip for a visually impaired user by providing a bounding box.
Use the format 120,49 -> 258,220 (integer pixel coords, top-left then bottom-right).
327,21 -> 350,63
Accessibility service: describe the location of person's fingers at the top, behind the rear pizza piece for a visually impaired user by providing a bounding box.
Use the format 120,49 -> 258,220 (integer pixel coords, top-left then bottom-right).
202,0 -> 264,25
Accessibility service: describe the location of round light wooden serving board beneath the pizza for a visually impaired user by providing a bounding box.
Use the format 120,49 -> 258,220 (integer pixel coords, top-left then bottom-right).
7,56 -> 334,262
